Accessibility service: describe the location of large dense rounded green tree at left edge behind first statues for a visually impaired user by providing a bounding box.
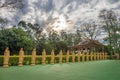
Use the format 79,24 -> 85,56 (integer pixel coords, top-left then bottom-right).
0,28 -> 33,55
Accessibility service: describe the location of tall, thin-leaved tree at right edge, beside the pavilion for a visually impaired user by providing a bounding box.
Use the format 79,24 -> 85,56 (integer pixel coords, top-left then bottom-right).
99,9 -> 120,54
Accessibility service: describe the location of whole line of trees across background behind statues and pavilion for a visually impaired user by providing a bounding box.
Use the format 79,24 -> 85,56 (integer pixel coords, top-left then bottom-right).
0,9 -> 120,55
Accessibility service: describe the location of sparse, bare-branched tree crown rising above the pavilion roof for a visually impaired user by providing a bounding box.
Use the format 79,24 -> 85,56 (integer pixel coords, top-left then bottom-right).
77,23 -> 101,40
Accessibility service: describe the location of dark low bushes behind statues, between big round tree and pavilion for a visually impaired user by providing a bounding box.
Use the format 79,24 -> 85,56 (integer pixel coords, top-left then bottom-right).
36,41 -> 67,55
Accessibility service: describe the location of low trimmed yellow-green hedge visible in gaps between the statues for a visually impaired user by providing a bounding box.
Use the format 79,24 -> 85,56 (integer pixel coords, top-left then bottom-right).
0,55 -> 109,66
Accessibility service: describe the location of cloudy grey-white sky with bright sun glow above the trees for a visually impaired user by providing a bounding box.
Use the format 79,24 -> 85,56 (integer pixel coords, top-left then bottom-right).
0,0 -> 120,30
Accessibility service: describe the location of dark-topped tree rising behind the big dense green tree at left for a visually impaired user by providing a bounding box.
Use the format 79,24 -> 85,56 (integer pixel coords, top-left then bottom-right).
18,21 -> 43,41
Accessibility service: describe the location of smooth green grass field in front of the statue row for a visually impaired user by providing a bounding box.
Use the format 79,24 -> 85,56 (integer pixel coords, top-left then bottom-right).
0,60 -> 120,80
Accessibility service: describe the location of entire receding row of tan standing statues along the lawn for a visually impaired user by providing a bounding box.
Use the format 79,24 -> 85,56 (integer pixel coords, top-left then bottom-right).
3,48 -> 107,68
